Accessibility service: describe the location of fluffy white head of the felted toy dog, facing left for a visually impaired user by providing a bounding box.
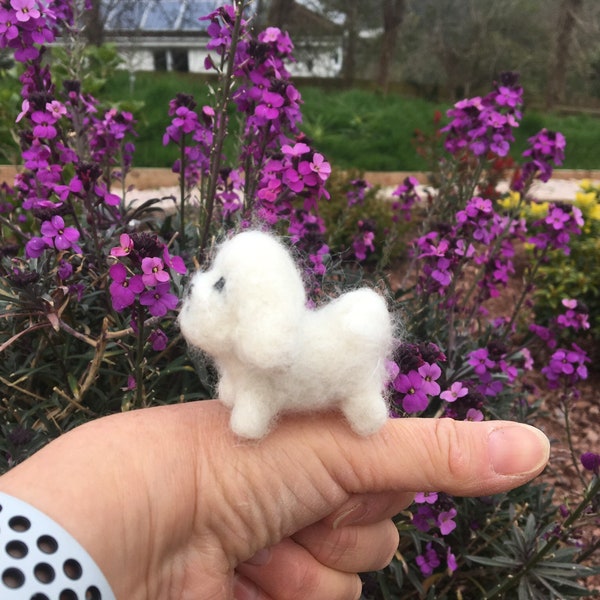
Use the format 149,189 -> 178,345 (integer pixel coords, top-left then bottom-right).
179,231 -> 306,368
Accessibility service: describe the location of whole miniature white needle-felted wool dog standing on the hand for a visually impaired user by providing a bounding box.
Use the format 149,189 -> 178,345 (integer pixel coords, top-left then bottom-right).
179,231 -> 393,439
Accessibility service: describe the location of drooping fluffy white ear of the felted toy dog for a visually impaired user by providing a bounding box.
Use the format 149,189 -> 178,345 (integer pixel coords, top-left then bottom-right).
226,236 -> 306,369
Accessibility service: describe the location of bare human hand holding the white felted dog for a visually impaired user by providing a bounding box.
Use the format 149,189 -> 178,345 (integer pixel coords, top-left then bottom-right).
0,401 -> 549,600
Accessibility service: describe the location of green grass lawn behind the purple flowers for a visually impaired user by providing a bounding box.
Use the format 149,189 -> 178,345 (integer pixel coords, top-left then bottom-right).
102,72 -> 600,171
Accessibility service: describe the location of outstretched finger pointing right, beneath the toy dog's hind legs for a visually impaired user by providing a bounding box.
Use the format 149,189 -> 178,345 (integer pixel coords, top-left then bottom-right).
302,419 -> 550,496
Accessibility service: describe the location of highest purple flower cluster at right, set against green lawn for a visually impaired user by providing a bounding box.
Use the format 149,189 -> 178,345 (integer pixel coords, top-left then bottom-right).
441,73 -> 523,156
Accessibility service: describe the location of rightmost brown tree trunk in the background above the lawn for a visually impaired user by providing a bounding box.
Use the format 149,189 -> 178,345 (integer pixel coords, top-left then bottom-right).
546,0 -> 584,109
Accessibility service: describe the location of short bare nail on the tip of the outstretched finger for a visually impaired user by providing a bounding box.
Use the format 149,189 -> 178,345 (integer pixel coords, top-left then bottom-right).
488,424 -> 550,475
